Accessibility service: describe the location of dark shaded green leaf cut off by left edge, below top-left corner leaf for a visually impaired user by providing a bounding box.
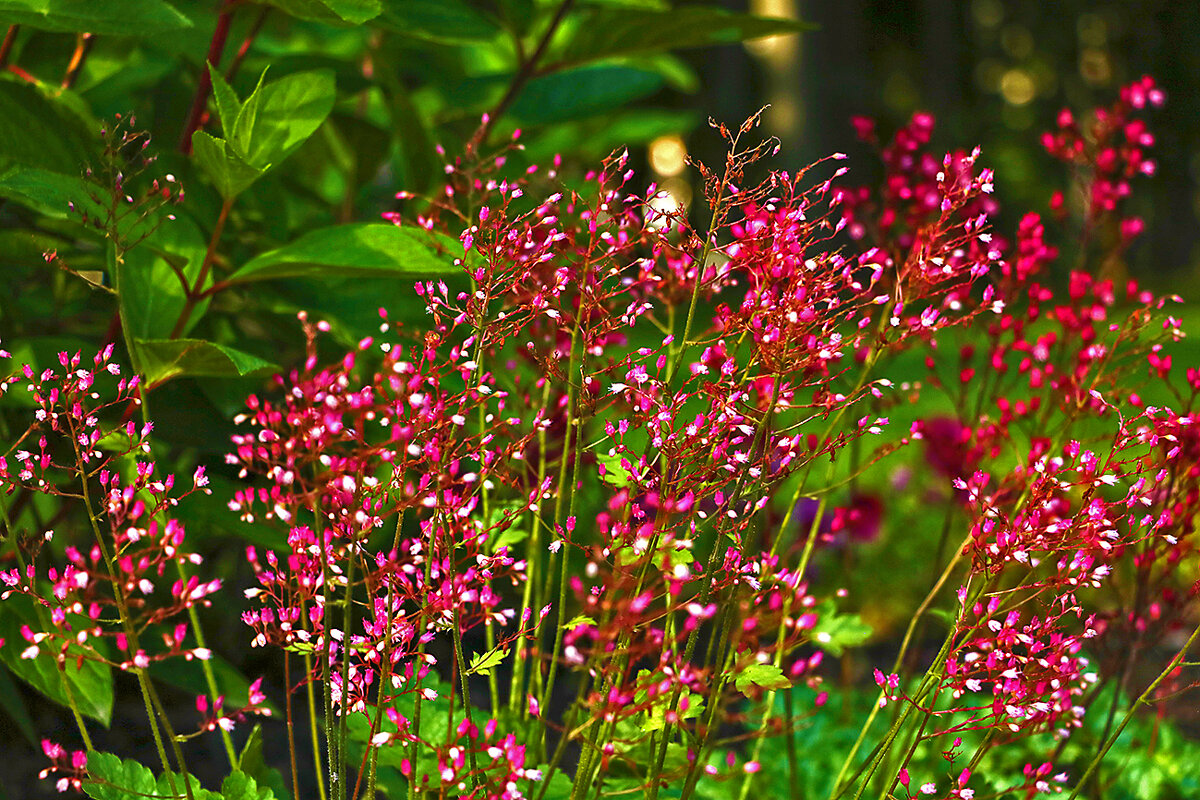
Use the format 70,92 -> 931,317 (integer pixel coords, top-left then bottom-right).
0,80 -> 98,175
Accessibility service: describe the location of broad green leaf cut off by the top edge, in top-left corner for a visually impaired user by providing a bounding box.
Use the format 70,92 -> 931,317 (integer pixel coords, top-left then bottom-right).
0,0 -> 192,36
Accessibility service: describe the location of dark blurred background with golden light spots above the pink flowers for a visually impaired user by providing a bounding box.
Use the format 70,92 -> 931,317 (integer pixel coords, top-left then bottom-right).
667,0 -> 1200,300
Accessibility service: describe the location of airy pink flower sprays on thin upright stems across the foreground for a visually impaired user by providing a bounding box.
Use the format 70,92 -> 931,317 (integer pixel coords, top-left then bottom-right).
0,78 -> 1200,799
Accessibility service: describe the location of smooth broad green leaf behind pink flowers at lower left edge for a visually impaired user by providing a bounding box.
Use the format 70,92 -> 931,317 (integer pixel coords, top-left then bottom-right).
0,595 -> 113,727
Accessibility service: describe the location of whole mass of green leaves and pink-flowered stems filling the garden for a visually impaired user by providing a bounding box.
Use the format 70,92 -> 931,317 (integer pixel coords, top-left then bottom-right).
0,0 -> 1200,800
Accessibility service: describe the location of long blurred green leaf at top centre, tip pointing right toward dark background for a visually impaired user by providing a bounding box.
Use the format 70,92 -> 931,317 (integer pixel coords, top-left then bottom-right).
550,6 -> 812,66
